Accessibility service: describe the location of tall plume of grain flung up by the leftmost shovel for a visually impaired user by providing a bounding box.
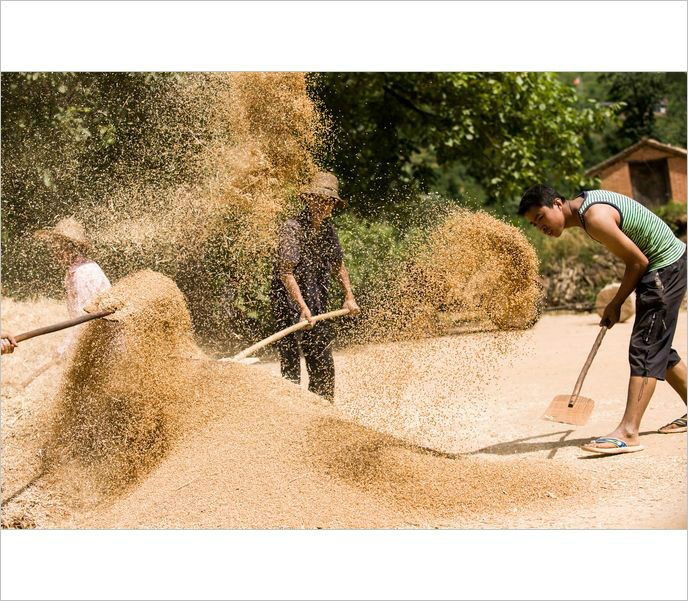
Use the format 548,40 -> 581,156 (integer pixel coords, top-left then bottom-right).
47,271 -> 202,493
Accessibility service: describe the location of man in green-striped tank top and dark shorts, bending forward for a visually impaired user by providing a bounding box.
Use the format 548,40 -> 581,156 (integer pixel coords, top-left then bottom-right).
518,184 -> 686,454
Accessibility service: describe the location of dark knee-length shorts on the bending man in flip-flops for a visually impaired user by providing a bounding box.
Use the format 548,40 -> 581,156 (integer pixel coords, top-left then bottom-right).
628,252 -> 686,380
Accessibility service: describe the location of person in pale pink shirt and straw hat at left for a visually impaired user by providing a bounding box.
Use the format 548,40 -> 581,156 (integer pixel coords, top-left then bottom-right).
36,217 -> 110,355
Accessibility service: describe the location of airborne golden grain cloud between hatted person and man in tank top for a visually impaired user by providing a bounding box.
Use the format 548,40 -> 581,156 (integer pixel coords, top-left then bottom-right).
364,209 -> 542,340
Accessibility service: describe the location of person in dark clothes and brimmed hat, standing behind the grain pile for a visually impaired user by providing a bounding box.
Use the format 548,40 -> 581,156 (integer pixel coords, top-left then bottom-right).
270,172 -> 360,401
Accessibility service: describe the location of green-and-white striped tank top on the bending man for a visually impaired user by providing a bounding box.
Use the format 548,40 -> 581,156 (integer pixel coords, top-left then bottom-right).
578,190 -> 686,271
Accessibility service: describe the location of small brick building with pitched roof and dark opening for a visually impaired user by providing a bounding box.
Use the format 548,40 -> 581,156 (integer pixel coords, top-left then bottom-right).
586,138 -> 688,207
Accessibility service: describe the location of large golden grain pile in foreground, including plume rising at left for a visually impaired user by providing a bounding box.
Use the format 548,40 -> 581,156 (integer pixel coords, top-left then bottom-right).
3,271 -> 585,528
